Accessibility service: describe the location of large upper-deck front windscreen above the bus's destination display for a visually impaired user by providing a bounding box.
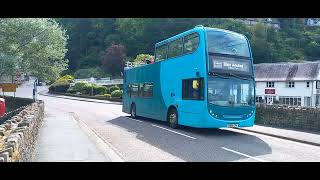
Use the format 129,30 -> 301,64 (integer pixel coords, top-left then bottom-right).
207,30 -> 250,57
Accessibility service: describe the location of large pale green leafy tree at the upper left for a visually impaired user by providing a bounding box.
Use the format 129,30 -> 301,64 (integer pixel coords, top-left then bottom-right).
0,18 -> 68,80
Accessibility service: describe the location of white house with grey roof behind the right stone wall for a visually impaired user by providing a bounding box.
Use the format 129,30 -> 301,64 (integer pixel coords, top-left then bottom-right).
255,61 -> 320,107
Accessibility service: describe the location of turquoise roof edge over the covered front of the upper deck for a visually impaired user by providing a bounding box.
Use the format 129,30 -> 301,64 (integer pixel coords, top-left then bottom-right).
155,25 -> 243,47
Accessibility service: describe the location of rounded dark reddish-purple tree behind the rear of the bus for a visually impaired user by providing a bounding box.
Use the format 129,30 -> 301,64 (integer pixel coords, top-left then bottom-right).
101,44 -> 127,76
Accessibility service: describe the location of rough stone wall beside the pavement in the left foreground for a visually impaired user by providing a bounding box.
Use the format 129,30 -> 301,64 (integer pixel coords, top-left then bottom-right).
0,101 -> 44,162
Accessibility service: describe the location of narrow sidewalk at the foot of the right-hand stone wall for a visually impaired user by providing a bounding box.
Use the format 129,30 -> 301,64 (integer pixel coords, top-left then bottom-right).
236,125 -> 320,146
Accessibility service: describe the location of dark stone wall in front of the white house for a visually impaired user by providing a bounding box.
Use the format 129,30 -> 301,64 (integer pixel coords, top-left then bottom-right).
255,105 -> 320,132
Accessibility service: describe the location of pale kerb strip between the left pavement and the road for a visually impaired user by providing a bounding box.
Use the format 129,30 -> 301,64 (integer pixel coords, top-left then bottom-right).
72,113 -> 125,162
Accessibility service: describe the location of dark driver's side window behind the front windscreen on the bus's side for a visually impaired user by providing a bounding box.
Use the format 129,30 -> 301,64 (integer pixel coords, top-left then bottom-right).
182,78 -> 204,100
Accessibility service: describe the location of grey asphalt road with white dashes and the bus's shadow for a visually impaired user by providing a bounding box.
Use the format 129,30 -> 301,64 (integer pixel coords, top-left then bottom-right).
38,89 -> 320,162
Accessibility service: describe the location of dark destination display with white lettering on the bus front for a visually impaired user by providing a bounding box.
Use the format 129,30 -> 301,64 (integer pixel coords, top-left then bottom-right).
210,56 -> 251,72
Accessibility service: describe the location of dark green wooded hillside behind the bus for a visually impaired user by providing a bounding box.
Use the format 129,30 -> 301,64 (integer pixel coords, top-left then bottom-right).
57,18 -> 320,75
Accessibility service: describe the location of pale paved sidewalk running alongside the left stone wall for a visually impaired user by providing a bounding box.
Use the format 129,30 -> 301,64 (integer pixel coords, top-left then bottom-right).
34,109 -> 111,162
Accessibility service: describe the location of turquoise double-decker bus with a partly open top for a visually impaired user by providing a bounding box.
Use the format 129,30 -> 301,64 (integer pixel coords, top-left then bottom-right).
122,25 -> 256,128
